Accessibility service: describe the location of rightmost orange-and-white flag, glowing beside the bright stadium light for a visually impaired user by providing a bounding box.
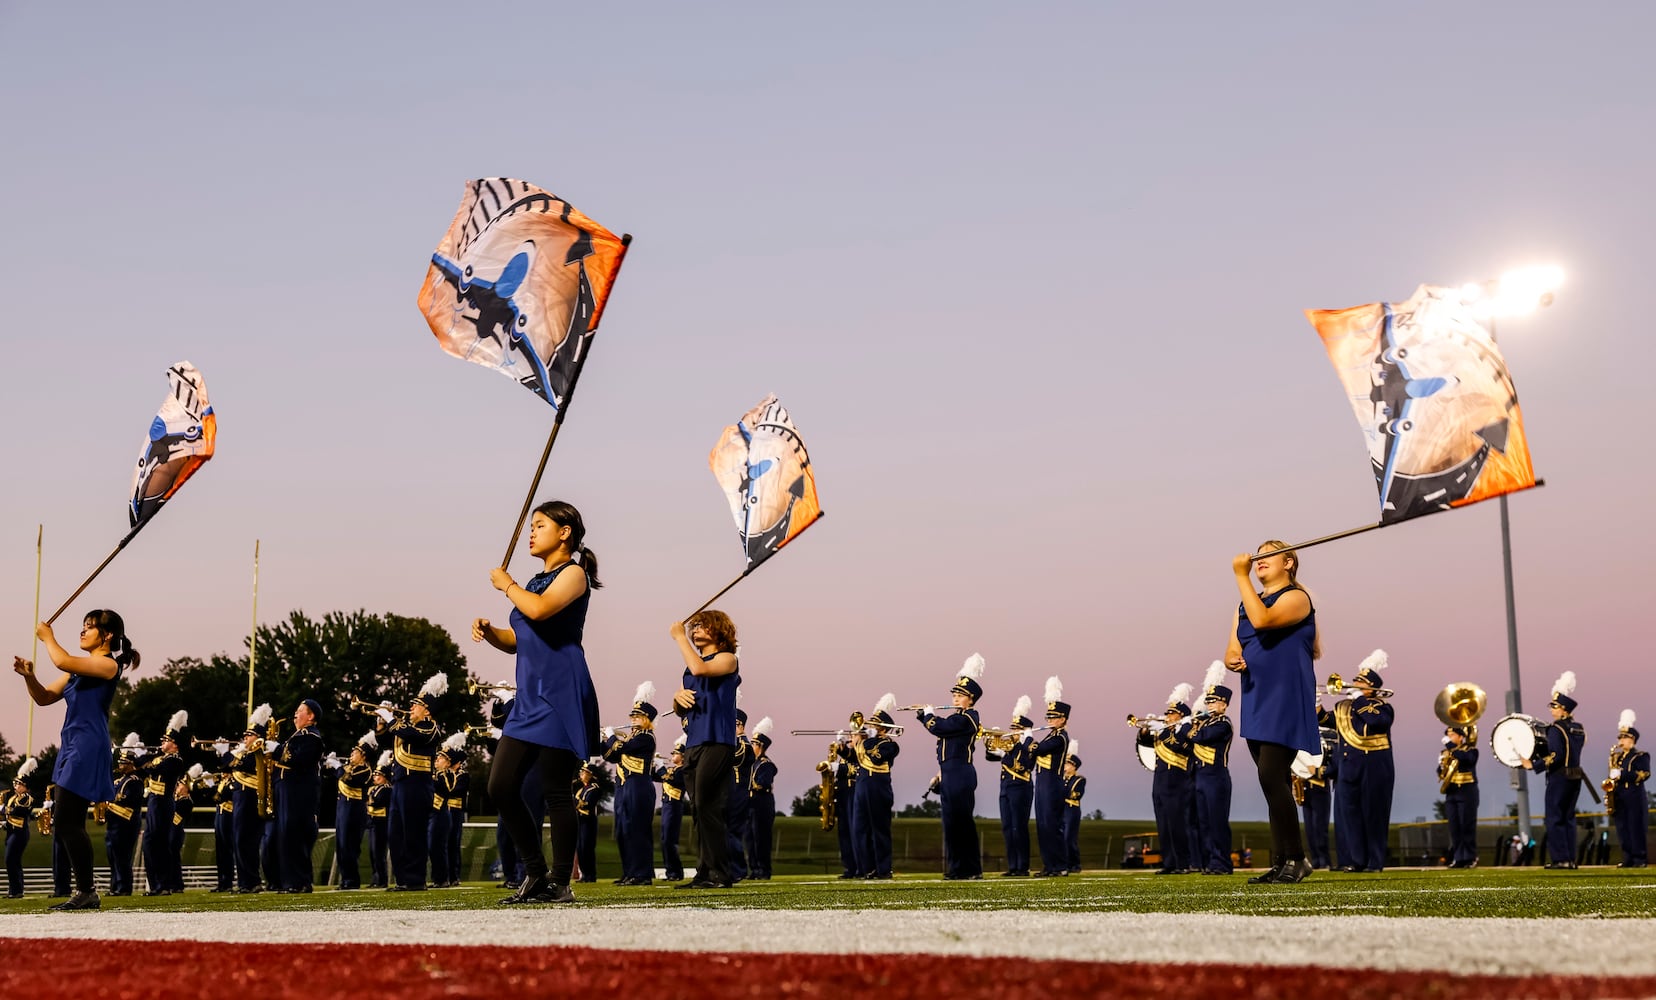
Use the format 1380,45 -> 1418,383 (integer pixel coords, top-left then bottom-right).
1305,285 -> 1535,525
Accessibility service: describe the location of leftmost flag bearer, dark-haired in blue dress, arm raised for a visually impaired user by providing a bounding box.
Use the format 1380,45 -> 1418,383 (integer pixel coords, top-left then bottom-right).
12,611 -> 139,909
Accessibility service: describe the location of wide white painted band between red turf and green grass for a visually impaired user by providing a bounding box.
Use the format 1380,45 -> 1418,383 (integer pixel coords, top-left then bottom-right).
0,906 -> 1656,975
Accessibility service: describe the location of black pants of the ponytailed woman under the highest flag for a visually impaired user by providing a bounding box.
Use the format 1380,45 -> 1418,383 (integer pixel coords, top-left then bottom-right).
489,737 -> 580,886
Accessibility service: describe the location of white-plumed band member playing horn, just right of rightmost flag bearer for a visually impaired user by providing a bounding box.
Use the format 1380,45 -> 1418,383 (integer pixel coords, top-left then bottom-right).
1317,649 -> 1398,871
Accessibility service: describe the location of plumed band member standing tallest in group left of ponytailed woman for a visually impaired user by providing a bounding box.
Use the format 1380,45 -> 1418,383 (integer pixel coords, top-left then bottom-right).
376,674 -> 449,892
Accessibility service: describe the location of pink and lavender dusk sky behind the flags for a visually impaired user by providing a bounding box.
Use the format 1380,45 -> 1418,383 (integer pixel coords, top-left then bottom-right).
0,3 -> 1656,821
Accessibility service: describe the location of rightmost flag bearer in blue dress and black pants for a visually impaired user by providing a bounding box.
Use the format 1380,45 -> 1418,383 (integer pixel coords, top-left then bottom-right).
1225,541 -> 1321,882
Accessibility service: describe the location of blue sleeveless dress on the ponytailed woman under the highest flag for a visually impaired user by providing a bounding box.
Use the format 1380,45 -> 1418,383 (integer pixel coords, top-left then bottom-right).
500,563 -> 599,760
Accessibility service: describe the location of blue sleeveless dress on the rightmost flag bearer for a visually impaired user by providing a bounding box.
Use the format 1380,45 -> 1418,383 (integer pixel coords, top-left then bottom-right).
1237,588 -> 1323,753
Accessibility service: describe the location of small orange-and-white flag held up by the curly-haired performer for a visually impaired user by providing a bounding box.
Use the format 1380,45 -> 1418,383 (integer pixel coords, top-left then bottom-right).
707,396 -> 821,573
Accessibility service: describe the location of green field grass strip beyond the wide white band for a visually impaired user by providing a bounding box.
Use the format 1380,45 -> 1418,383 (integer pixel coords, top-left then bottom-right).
0,868 -> 1656,932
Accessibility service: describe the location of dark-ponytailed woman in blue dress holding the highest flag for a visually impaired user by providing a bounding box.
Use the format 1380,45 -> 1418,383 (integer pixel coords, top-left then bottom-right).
472,500 -> 603,904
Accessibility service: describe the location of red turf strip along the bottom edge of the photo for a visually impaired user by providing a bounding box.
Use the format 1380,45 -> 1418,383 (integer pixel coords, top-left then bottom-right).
0,927 -> 1656,1000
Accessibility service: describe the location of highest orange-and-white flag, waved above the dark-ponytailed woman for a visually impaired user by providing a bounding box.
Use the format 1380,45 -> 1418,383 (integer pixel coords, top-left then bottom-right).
419,177 -> 626,411
